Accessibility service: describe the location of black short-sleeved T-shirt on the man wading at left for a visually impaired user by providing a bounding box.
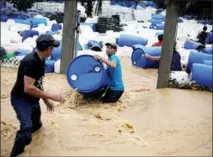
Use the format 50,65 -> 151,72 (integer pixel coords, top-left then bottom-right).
11,52 -> 45,103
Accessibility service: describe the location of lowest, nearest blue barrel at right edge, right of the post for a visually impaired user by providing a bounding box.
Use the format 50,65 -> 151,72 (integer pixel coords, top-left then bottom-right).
191,63 -> 212,89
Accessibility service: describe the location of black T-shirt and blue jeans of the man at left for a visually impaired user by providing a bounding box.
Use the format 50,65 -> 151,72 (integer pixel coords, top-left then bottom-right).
10,52 -> 45,157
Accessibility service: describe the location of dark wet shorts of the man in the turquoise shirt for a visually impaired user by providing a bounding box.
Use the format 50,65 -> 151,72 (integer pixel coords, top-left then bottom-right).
102,88 -> 124,103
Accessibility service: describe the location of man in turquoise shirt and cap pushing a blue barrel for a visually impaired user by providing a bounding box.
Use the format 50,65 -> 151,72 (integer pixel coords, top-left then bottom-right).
94,43 -> 124,103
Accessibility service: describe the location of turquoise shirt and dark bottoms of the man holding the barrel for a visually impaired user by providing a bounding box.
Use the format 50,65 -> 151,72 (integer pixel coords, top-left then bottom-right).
103,55 -> 124,103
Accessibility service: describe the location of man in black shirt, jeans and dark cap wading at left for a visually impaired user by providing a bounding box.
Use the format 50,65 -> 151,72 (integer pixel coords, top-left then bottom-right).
10,34 -> 64,157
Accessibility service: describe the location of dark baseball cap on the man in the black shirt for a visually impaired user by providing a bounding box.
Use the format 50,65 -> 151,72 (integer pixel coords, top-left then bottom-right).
36,34 -> 60,50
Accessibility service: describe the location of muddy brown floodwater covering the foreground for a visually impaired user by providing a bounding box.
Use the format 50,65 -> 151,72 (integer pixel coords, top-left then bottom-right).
1,58 -> 212,156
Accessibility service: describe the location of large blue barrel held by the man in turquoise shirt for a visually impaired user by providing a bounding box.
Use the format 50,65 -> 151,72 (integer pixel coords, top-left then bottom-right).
67,55 -> 108,96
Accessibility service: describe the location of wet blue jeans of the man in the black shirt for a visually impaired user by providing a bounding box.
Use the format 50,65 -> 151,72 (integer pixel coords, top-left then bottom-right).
11,97 -> 42,157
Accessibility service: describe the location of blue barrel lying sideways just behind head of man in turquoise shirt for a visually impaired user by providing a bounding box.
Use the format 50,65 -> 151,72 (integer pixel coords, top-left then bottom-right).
116,34 -> 148,47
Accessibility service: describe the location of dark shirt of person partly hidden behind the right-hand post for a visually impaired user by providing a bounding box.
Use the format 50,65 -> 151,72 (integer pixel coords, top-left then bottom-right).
171,51 -> 182,71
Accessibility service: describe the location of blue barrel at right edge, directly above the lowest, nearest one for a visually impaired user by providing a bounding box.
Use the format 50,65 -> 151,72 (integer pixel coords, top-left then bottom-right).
187,50 -> 212,73
